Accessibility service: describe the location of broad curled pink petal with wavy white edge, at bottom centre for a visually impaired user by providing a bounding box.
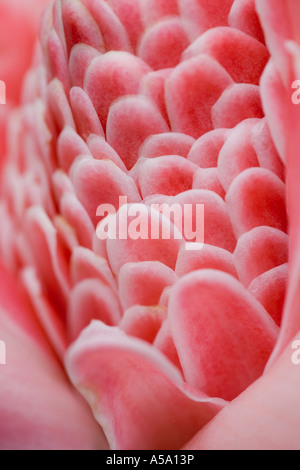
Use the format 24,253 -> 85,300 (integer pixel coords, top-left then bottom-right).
66,322 -> 225,450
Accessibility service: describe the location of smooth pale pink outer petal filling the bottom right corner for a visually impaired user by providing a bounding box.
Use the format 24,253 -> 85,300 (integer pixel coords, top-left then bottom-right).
185,333 -> 300,450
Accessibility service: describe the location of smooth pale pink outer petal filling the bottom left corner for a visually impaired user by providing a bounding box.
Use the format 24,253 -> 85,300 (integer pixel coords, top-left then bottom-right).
0,262 -> 106,450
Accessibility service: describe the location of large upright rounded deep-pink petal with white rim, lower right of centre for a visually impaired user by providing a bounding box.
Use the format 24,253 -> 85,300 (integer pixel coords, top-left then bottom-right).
168,270 -> 278,400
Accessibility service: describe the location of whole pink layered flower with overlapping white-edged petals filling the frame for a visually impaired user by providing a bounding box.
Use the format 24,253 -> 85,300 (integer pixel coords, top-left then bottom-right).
0,0 -> 300,449
